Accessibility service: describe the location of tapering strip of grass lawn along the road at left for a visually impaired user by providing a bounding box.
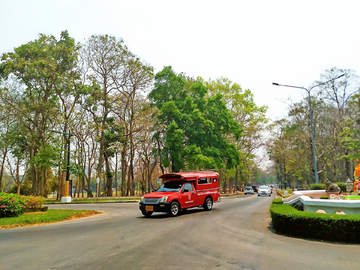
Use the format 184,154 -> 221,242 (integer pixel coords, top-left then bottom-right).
0,209 -> 101,230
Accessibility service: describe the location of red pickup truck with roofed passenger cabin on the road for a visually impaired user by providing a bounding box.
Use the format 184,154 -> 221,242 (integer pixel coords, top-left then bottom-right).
139,171 -> 220,217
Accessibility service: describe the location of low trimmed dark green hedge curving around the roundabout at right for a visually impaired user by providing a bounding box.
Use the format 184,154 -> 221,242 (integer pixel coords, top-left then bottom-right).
270,199 -> 360,243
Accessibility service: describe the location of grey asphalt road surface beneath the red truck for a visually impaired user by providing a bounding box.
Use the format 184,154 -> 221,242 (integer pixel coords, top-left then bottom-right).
0,195 -> 360,270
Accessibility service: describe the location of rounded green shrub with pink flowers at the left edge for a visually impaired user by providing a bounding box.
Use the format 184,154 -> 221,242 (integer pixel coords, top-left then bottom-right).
0,193 -> 26,218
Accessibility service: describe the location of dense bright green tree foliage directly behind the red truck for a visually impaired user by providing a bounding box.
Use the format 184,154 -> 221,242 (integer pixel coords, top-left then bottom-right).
149,66 -> 241,172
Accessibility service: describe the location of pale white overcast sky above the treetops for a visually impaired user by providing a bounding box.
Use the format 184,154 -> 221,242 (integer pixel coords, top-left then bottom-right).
0,0 -> 360,120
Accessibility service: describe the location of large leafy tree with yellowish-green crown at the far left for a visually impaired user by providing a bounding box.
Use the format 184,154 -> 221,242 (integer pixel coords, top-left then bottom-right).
0,31 -> 77,195
